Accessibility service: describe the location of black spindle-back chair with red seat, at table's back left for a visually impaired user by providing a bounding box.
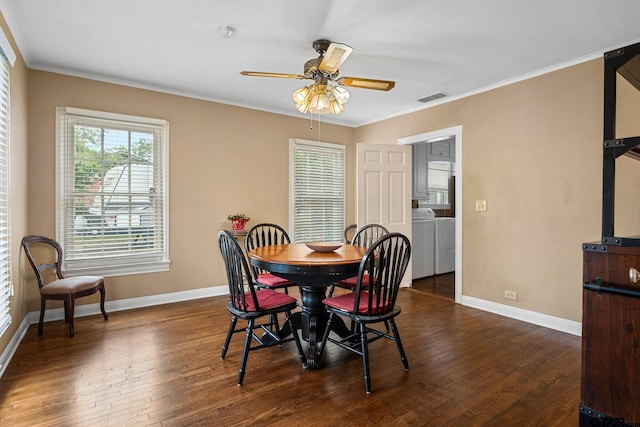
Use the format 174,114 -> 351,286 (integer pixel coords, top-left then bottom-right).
244,223 -> 296,294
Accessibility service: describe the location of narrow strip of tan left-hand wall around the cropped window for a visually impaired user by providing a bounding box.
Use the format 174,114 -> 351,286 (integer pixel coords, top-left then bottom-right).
0,15 -> 28,354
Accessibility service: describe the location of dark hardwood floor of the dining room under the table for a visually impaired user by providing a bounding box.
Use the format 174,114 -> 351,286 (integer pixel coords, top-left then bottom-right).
0,289 -> 581,426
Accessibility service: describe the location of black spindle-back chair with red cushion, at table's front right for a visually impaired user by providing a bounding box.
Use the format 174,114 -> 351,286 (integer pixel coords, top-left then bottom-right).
319,233 -> 411,394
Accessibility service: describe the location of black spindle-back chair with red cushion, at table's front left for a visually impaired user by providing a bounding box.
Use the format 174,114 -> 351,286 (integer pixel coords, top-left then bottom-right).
218,230 -> 307,385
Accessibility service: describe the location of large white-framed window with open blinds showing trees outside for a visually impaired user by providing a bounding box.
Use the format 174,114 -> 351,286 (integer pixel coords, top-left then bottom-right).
56,107 -> 169,276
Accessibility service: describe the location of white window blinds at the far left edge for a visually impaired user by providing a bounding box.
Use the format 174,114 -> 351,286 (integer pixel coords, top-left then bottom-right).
0,57 -> 11,335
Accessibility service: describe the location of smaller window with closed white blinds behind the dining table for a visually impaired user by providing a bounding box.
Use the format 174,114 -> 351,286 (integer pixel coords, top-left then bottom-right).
289,139 -> 345,242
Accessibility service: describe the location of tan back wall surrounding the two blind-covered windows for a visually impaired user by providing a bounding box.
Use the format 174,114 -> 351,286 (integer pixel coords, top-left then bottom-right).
28,71 -> 355,311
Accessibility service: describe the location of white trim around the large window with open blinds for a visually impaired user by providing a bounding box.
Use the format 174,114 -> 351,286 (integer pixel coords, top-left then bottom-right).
55,107 -> 171,277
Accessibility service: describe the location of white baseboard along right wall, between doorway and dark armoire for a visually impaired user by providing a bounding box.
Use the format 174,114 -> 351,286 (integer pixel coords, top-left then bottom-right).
461,295 -> 582,336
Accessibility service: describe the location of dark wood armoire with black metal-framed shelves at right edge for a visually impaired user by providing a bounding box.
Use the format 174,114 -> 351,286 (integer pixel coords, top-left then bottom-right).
579,43 -> 640,427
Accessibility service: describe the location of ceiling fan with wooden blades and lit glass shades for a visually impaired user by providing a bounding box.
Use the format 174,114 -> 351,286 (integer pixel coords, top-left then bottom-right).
240,39 -> 395,114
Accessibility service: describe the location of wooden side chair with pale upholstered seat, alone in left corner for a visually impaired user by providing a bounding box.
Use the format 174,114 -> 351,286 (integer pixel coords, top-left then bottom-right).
22,235 -> 109,337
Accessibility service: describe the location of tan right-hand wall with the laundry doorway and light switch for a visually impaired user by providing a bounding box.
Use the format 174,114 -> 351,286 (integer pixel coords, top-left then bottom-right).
356,60 -> 603,321
